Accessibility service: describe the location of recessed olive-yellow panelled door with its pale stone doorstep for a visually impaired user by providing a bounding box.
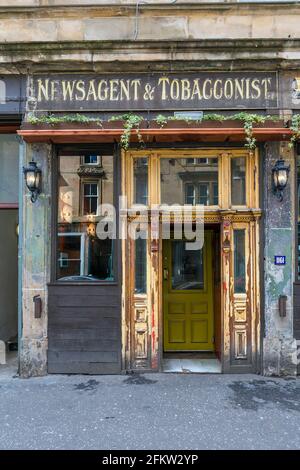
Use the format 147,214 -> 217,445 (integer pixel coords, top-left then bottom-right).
162,227 -> 221,373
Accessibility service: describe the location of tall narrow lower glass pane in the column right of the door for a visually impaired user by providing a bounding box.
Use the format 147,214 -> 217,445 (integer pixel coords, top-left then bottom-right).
234,230 -> 246,294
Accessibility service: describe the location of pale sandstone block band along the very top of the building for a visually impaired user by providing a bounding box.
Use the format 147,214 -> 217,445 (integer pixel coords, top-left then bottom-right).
0,1 -> 300,43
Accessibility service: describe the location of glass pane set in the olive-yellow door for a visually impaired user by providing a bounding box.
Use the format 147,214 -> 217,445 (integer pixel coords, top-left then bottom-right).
171,240 -> 204,290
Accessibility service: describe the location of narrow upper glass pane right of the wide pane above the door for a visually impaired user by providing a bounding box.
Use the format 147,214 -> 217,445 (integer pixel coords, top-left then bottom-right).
231,157 -> 246,206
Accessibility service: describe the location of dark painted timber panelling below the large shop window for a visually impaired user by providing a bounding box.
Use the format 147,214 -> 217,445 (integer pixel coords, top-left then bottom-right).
48,284 -> 121,374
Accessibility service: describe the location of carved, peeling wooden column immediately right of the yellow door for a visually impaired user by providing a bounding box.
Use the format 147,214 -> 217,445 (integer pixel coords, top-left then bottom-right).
221,211 -> 260,372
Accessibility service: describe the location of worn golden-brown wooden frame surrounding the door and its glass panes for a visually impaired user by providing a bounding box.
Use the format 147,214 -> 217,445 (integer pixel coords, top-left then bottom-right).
122,146 -> 261,372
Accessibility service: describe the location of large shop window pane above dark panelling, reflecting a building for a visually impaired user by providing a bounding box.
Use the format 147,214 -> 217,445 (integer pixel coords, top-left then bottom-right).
57,155 -> 114,281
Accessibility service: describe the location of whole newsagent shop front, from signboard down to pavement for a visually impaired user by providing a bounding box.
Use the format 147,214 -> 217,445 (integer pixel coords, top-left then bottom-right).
20,72 -> 294,375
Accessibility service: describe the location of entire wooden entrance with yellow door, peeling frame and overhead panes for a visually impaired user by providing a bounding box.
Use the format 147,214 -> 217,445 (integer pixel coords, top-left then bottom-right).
122,148 -> 261,373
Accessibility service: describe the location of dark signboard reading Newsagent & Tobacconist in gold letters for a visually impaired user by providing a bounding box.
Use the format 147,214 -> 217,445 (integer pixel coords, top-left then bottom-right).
31,72 -> 278,112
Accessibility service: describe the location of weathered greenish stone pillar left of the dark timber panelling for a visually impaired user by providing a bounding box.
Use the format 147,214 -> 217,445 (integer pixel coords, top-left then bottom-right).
20,144 -> 51,377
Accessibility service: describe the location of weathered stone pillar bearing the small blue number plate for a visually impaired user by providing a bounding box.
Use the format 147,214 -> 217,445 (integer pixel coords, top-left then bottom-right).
263,143 -> 296,375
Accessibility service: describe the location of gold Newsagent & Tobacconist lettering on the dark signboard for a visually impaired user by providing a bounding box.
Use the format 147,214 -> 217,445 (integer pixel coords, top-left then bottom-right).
34,74 -> 276,109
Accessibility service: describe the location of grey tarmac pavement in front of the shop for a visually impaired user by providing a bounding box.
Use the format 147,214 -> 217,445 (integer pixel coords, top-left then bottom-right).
0,363 -> 300,450
